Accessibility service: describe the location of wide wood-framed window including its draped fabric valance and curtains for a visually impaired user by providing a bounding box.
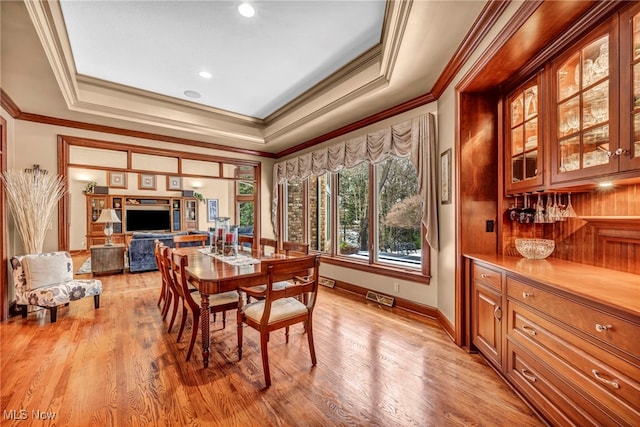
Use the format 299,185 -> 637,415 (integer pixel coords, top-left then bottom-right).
272,113 -> 439,283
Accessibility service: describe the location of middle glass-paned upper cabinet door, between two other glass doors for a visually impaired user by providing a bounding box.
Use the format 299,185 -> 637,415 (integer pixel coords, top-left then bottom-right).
552,28 -> 618,181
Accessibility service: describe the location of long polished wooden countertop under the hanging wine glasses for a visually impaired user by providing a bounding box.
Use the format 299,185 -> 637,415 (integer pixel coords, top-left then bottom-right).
465,254 -> 640,323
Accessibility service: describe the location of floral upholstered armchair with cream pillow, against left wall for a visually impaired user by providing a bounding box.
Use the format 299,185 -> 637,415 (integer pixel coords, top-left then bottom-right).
11,251 -> 102,323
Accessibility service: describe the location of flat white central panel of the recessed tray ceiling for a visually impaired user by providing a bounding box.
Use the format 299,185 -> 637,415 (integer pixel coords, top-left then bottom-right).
60,0 -> 385,119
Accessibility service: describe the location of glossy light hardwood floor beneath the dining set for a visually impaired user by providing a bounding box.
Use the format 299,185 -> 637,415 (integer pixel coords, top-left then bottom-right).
0,257 -> 542,427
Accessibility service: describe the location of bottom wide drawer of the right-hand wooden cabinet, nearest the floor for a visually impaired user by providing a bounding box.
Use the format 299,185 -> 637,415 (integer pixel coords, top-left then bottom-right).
507,341 -> 602,426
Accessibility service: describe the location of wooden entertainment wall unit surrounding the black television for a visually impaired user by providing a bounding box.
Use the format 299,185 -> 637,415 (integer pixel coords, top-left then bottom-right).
86,194 -> 198,248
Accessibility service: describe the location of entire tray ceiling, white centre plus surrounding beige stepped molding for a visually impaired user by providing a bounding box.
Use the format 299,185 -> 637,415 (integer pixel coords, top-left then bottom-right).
0,0 -> 485,153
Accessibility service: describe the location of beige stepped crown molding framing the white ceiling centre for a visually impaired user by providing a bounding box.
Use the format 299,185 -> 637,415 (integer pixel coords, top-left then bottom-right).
26,0 -> 413,146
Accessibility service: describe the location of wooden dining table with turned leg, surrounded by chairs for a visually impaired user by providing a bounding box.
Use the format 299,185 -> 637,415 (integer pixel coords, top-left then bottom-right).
175,247 -> 288,368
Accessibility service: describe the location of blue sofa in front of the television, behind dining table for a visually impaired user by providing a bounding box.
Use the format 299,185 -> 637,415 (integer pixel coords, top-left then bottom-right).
127,230 -> 211,273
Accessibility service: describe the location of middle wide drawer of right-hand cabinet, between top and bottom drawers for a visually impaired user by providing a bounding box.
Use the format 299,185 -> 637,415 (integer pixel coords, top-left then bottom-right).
508,301 -> 640,425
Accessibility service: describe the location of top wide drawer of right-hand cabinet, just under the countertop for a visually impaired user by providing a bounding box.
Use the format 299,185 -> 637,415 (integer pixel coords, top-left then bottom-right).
507,277 -> 640,358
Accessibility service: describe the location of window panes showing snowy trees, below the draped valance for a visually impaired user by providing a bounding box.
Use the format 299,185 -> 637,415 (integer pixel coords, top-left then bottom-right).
280,157 -> 428,273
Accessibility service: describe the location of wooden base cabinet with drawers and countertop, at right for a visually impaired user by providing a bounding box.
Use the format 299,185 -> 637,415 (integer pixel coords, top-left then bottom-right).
467,255 -> 640,426
